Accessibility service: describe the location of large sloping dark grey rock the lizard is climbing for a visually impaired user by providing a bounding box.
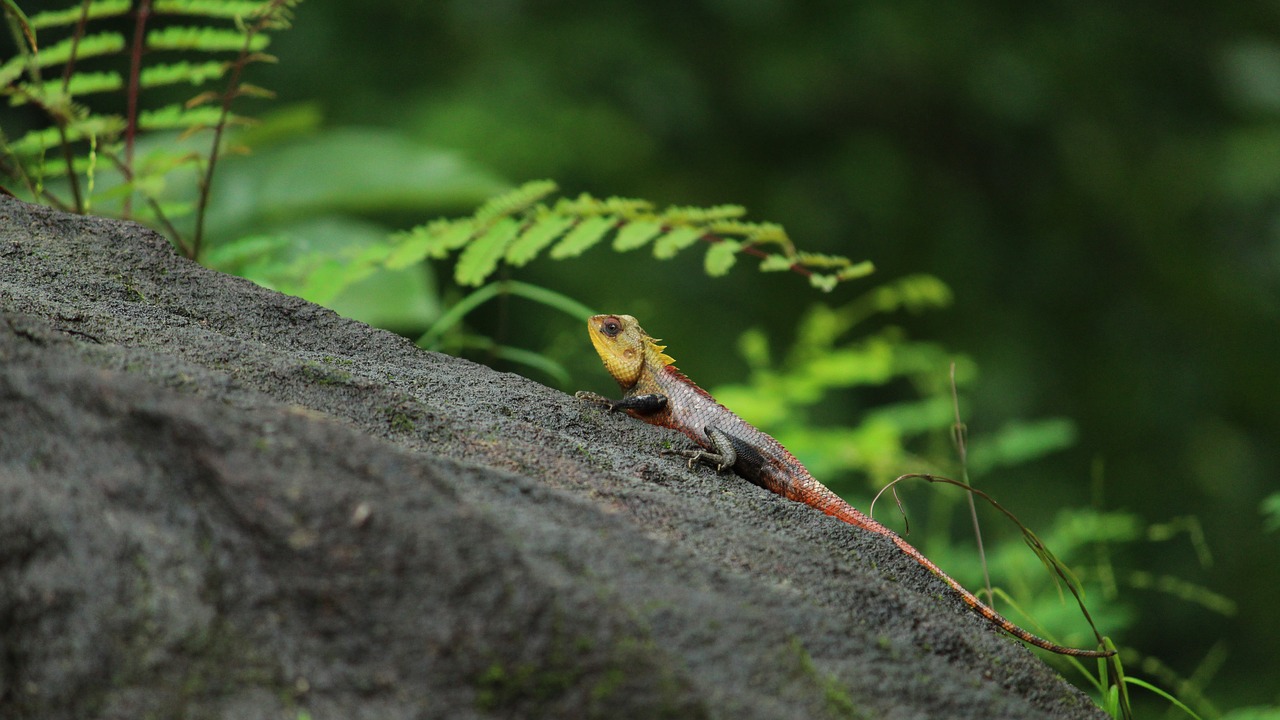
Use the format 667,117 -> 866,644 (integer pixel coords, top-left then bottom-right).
0,197 -> 1105,719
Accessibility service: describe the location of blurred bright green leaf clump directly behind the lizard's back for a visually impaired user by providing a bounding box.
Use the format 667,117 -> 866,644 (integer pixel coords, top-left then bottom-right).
711,275 -> 974,486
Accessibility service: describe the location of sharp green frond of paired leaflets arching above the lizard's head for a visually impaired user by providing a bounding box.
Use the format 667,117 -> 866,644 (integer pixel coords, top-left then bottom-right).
394,181 -> 873,291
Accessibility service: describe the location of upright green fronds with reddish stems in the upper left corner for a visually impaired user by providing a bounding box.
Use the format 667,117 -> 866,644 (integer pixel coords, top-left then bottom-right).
0,0 -> 298,258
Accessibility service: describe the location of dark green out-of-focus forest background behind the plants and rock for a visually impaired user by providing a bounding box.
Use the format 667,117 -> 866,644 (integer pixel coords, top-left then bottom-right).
5,0 -> 1280,717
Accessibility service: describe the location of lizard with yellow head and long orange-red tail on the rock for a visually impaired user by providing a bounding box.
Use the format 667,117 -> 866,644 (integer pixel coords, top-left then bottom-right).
577,315 -> 1115,657
